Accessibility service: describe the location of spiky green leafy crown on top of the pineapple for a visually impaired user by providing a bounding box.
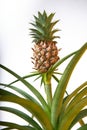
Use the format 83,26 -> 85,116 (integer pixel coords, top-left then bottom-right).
30,11 -> 60,43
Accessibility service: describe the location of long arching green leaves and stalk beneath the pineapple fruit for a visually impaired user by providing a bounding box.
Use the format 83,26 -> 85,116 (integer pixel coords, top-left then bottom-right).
0,42 -> 87,130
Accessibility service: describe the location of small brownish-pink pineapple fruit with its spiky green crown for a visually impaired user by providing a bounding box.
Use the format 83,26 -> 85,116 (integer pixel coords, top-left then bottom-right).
30,11 -> 59,73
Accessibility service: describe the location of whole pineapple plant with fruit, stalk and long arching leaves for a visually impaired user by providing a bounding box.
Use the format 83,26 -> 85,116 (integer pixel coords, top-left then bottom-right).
0,11 -> 87,130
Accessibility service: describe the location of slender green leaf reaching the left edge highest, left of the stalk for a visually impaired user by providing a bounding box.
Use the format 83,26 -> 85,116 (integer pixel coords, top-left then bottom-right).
0,65 -> 49,114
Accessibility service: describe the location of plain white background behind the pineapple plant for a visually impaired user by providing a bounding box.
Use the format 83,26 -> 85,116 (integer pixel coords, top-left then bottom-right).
0,0 -> 87,129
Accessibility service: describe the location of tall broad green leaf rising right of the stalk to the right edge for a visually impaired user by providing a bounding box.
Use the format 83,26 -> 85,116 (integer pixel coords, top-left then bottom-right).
51,43 -> 87,127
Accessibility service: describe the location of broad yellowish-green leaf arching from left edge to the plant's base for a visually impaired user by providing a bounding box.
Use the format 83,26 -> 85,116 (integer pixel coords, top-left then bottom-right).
0,95 -> 53,130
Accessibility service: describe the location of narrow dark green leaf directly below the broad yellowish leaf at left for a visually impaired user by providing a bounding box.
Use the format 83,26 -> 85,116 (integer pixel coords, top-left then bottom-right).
0,106 -> 42,130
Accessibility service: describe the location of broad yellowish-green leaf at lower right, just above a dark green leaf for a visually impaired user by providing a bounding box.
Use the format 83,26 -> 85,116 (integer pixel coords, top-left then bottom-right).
58,97 -> 87,130
